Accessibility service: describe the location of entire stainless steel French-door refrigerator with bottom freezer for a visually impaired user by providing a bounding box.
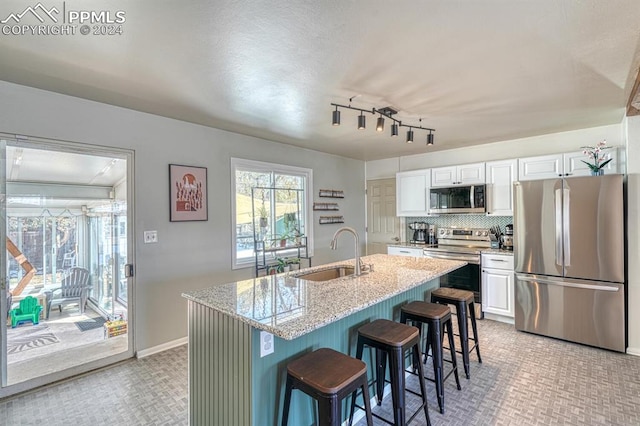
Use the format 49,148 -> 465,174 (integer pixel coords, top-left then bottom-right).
513,175 -> 626,352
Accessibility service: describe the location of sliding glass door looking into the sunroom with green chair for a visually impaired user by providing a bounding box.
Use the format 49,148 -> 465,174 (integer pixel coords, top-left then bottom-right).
0,135 -> 133,398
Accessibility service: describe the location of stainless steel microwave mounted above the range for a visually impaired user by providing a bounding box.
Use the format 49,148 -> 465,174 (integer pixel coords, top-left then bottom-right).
429,185 -> 487,213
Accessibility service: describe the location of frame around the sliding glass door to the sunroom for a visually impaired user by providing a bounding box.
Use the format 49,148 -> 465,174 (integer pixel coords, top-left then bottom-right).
0,133 -> 136,398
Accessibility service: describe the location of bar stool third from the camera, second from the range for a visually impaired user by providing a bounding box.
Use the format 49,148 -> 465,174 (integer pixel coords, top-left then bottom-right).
400,301 -> 462,414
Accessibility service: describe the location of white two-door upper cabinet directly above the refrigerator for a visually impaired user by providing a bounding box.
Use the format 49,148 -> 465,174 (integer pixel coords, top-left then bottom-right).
518,148 -> 619,180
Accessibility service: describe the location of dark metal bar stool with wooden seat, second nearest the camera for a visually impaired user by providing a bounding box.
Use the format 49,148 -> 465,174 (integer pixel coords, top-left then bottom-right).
349,319 -> 431,426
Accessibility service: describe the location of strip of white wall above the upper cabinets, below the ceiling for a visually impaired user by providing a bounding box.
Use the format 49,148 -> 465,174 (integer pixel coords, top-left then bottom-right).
367,124 -> 625,179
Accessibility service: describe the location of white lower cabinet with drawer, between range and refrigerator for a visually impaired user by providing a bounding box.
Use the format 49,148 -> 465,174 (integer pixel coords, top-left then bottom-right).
482,254 -> 515,323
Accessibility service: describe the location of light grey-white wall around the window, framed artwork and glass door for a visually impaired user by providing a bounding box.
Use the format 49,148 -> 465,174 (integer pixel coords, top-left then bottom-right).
0,82 -> 365,350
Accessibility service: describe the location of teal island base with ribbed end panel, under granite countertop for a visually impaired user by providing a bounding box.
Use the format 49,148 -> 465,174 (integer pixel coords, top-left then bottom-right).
188,278 -> 439,426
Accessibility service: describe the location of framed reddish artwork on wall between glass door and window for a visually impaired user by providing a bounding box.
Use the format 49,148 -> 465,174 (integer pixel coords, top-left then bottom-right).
169,164 -> 208,222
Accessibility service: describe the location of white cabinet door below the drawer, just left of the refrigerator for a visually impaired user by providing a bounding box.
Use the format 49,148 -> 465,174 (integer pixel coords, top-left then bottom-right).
482,269 -> 514,318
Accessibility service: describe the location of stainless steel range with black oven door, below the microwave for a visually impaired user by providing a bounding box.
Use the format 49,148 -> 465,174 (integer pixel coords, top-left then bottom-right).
424,228 -> 491,318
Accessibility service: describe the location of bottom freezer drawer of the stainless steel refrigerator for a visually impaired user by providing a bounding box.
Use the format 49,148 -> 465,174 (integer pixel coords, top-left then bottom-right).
515,274 -> 626,352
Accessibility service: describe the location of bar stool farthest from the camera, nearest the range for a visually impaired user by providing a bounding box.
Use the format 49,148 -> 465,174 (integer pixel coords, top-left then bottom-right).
431,287 -> 482,379
